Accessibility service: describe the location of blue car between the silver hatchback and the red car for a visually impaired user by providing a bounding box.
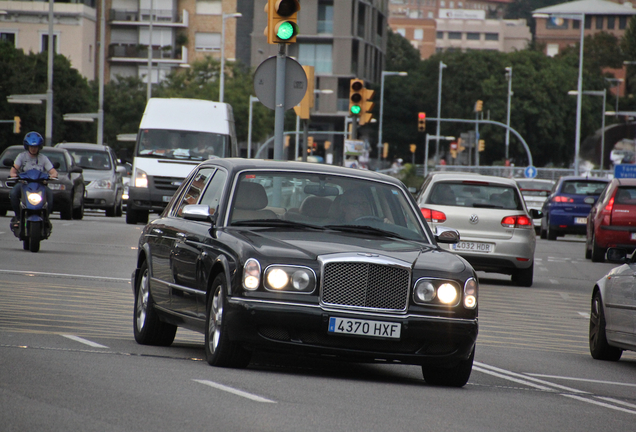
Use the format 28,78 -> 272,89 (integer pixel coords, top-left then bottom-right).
540,176 -> 609,240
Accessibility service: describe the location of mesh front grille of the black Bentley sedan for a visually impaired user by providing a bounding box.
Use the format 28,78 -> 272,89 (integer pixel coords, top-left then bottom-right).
322,262 -> 409,311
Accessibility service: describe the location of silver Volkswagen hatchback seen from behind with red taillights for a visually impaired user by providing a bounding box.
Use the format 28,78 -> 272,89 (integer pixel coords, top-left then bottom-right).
417,173 -> 541,286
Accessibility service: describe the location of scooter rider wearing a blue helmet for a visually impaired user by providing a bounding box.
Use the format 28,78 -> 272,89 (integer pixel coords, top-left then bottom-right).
9,132 -> 57,225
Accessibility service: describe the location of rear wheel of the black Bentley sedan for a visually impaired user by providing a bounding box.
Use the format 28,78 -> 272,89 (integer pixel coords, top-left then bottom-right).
133,262 -> 177,346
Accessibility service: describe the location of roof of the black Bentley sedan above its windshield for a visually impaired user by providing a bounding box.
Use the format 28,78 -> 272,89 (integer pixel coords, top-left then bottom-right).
201,158 -> 402,185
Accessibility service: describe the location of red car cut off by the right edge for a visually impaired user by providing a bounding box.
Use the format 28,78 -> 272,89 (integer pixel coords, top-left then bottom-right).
585,178 -> 636,262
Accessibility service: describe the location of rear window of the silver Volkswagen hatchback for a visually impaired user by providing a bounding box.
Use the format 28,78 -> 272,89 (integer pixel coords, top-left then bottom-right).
427,181 -> 523,210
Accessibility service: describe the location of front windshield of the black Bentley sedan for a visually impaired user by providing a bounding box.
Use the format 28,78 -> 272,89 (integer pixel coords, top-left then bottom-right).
230,172 -> 428,241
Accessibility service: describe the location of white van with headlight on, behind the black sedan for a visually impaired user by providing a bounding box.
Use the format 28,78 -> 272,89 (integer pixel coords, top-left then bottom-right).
126,98 -> 238,224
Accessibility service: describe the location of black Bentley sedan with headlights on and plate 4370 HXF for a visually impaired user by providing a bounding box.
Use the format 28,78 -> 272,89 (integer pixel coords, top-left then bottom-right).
132,158 -> 478,387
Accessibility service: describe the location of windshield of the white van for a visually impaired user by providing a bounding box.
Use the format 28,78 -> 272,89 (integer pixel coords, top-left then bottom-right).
135,129 -> 230,160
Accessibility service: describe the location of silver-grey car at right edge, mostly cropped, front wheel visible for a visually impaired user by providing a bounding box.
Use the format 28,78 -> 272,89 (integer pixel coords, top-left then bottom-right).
589,248 -> 636,361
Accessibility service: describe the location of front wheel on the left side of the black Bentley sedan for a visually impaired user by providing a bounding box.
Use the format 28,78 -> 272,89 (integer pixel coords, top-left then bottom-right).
205,274 -> 251,368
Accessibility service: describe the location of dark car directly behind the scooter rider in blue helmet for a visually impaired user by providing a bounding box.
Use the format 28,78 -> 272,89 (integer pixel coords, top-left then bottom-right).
0,146 -> 84,220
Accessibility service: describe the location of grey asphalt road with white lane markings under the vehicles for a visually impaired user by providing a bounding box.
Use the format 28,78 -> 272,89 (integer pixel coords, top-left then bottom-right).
0,213 -> 636,432
